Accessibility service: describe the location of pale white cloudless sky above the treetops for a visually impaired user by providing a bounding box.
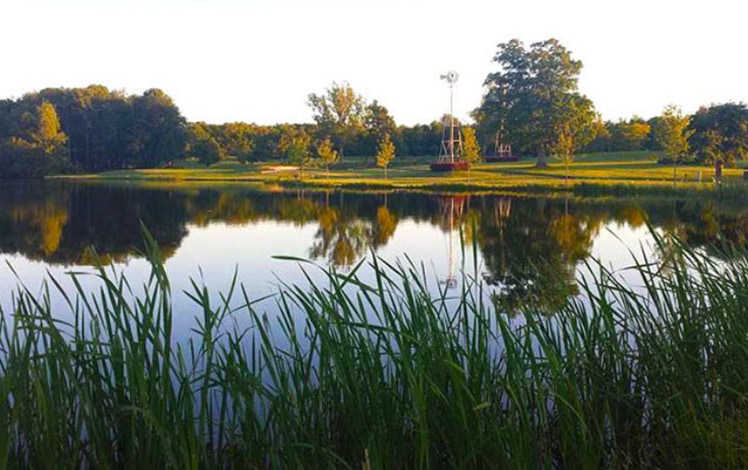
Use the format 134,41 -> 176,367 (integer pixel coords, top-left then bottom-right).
0,0 -> 748,125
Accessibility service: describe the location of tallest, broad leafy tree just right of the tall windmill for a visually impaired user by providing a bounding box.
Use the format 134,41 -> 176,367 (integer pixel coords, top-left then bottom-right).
475,39 -> 596,166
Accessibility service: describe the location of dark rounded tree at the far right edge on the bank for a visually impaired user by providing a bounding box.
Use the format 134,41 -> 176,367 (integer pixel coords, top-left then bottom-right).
688,103 -> 748,164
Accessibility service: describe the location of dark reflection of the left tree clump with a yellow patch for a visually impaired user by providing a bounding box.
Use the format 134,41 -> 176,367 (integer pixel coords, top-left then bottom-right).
0,184 -> 186,264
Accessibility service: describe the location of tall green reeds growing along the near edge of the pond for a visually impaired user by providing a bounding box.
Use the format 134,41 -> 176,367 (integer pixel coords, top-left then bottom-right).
0,231 -> 748,468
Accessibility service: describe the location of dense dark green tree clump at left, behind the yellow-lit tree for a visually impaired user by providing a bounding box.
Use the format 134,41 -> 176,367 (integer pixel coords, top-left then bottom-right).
0,85 -> 186,171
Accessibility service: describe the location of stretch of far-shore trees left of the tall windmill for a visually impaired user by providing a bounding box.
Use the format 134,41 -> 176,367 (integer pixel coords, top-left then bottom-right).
0,84 -> 456,178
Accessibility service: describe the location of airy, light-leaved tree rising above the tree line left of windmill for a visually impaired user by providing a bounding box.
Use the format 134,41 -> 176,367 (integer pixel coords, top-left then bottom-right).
308,82 -> 366,158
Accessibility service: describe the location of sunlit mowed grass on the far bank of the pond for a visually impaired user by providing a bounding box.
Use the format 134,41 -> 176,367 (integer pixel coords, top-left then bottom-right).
65,151 -> 743,194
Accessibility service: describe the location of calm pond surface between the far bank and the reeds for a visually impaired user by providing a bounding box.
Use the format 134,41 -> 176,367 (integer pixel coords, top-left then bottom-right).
0,183 -> 748,331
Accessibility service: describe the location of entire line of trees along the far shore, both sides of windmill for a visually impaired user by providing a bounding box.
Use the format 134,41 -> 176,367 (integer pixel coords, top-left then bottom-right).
0,39 -> 748,178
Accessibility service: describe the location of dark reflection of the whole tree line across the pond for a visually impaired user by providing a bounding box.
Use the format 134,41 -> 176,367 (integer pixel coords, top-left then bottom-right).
0,183 -> 748,312
